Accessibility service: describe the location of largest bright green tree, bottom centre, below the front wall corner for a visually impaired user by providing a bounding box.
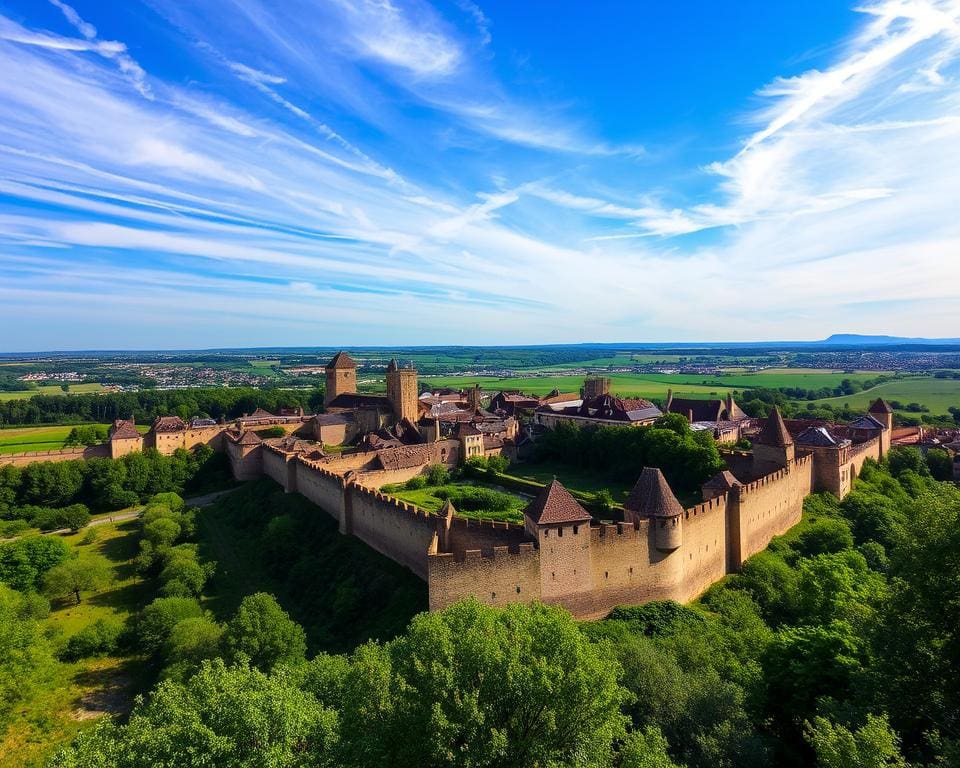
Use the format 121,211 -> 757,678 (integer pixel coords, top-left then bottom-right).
341,600 -> 626,768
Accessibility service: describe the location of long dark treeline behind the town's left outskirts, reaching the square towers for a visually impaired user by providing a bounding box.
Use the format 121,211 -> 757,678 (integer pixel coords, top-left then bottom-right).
0,387 -> 323,425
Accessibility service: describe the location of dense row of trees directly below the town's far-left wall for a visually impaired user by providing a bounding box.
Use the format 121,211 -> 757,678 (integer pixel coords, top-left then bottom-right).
0,446 -> 230,528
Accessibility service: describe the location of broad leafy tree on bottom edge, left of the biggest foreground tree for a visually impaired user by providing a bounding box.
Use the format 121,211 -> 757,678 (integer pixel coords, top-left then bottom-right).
51,660 -> 337,768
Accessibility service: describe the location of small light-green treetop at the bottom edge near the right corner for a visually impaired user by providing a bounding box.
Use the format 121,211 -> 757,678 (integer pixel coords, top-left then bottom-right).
805,714 -> 907,768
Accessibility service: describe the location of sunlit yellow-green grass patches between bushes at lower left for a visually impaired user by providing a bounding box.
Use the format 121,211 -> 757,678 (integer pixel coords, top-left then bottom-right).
0,520 -> 153,766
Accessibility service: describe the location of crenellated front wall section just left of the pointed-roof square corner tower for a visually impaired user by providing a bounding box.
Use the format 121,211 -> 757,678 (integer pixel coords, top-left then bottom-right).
427,543 -> 540,611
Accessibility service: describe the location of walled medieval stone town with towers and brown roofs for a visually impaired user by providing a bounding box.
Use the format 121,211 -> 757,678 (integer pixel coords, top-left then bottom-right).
0,352 -> 960,618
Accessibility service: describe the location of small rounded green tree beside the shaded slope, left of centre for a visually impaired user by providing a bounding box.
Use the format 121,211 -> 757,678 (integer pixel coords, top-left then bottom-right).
224,592 -> 307,670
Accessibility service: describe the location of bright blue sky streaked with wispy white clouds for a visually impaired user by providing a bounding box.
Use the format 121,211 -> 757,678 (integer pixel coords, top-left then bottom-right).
0,0 -> 960,351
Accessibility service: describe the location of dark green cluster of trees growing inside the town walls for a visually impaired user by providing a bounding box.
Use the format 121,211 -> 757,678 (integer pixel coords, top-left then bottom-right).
537,413 -> 725,492
